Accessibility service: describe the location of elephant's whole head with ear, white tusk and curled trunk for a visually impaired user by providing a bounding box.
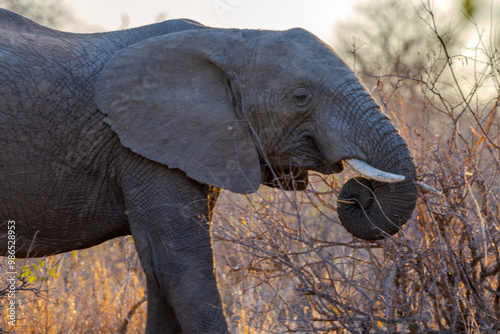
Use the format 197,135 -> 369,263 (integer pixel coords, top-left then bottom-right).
95,29 -> 417,240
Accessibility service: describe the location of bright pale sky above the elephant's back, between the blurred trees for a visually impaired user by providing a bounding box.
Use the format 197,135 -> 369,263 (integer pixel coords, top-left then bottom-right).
64,0 -> 367,41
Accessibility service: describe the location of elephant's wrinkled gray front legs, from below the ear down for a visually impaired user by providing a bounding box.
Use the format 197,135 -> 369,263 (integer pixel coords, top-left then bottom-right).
125,170 -> 228,334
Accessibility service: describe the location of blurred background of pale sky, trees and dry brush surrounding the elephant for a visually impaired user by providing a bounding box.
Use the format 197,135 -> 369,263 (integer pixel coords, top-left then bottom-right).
0,0 -> 500,334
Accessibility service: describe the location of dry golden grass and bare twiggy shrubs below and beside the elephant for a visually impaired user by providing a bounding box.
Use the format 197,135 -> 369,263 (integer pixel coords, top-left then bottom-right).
0,1 -> 500,333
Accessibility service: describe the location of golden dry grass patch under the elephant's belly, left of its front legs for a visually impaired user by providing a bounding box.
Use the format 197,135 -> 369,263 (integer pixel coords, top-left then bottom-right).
0,237 -> 146,333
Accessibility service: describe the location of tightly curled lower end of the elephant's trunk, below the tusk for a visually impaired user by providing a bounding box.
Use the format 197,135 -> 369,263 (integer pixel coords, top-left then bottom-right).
337,177 -> 417,240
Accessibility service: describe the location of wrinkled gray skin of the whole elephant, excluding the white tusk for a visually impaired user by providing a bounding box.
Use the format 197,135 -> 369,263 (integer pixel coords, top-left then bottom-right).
0,10 -> 417,333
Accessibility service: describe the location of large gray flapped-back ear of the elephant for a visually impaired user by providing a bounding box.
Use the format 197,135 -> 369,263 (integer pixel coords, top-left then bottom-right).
95,30 -> 261,193
